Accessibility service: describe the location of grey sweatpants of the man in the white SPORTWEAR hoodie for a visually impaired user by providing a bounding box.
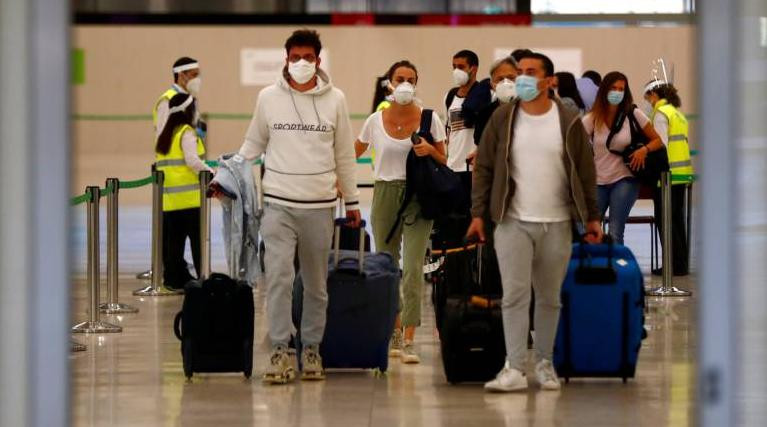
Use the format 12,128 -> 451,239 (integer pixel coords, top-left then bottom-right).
261,203 -> 333,346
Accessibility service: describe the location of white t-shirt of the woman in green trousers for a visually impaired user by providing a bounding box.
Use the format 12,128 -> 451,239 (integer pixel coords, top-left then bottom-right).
358,111 -> 445,181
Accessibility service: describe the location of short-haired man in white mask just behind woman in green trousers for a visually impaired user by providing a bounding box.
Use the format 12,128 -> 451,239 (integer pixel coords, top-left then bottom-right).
445,50 -> 491,172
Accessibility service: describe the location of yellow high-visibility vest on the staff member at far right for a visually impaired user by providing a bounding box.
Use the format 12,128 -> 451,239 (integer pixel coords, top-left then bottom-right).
650,99 -> 695,184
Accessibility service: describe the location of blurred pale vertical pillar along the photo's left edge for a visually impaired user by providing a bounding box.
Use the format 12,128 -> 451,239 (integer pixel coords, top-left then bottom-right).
0,0 -> 70,426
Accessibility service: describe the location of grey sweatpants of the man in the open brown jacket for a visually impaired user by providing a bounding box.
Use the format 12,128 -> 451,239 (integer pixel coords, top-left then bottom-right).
495,217 -> 572,372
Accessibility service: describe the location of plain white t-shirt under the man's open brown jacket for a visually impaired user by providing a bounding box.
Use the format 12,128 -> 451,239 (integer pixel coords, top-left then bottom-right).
509,103 -> 570,222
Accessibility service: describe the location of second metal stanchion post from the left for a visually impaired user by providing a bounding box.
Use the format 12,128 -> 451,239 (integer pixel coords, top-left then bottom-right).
100,178 -> 138,314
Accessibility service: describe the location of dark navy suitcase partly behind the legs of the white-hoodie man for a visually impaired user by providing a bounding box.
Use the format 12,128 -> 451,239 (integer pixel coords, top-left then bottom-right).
293,219 -> 400,372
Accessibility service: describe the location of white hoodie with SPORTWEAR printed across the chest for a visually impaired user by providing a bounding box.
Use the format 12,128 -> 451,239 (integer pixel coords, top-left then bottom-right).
240,69 -> 359,209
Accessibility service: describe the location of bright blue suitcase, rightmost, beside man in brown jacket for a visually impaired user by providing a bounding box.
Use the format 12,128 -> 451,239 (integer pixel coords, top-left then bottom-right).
554,243 -> 646,382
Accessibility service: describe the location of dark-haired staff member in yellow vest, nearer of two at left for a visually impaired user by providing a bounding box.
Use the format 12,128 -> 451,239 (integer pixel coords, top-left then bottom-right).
155,93 -> 211,289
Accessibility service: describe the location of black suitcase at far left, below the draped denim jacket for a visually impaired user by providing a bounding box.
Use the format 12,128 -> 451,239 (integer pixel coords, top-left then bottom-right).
173,273 -> 254,378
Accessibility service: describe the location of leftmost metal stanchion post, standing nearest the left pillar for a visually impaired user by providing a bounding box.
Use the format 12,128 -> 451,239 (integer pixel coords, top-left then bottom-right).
72,187 -> 122,334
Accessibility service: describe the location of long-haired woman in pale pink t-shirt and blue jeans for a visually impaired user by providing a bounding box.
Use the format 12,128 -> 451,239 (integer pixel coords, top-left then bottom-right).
583,71 -> 663,244
